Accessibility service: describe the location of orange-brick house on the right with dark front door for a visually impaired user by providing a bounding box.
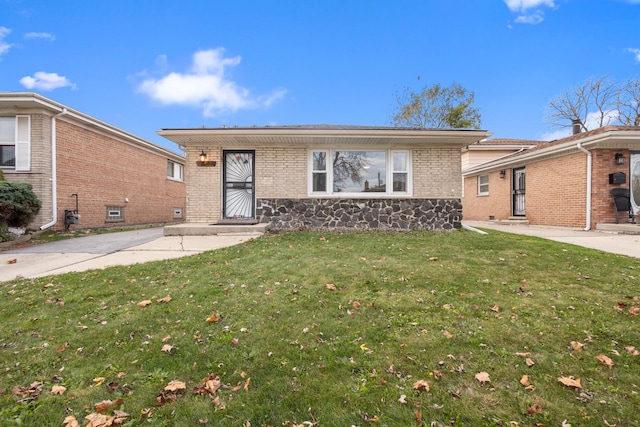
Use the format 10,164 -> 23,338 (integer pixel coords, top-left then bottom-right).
462,126 -> 640,229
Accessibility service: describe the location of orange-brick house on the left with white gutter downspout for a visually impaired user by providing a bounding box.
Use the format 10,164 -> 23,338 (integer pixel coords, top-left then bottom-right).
0,92 -> 186,230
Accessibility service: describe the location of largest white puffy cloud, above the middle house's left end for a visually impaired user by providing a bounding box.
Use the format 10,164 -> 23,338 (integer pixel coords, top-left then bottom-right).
138,48 -> 286,117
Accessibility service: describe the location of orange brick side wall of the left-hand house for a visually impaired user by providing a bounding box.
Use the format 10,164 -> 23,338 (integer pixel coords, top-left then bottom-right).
56,119 -> 186,229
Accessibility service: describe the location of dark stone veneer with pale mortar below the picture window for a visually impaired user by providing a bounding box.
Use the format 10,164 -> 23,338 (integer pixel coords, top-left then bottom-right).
256,199 -> 462,231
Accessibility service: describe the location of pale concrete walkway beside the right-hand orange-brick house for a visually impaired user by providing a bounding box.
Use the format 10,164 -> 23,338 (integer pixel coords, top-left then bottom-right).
463,221 -> 640,258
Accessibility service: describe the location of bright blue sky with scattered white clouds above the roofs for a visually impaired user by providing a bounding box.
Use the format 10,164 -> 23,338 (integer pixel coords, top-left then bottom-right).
0,0 -> 640,154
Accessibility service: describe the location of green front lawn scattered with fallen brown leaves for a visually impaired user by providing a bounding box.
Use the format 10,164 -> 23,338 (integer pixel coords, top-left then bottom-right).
0,231 -> 640,427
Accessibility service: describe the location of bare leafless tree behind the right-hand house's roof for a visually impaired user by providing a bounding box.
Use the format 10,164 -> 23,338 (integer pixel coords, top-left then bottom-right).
547,76 -> 640,131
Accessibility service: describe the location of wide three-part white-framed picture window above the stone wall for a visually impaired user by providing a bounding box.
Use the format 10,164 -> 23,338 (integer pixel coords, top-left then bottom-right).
309,149 -> 411,196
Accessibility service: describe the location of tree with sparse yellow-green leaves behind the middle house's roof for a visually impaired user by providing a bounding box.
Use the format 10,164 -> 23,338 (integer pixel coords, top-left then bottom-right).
391,82 -> 481,129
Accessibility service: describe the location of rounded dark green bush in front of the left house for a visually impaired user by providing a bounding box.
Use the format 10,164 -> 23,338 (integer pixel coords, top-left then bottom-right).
0,181 -> 42,231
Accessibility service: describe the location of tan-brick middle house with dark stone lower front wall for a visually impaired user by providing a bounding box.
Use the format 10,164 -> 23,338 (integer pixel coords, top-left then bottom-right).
158,125 -> 490,230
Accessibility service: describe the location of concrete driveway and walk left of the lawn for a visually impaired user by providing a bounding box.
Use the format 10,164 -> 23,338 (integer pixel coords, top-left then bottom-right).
0,228 -> 260,281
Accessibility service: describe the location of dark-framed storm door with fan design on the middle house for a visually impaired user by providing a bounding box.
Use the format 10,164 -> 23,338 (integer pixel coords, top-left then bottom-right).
223,150 -> 255,219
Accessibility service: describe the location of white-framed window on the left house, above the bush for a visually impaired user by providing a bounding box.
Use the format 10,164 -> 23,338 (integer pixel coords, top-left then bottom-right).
0,116 -> 31,171
